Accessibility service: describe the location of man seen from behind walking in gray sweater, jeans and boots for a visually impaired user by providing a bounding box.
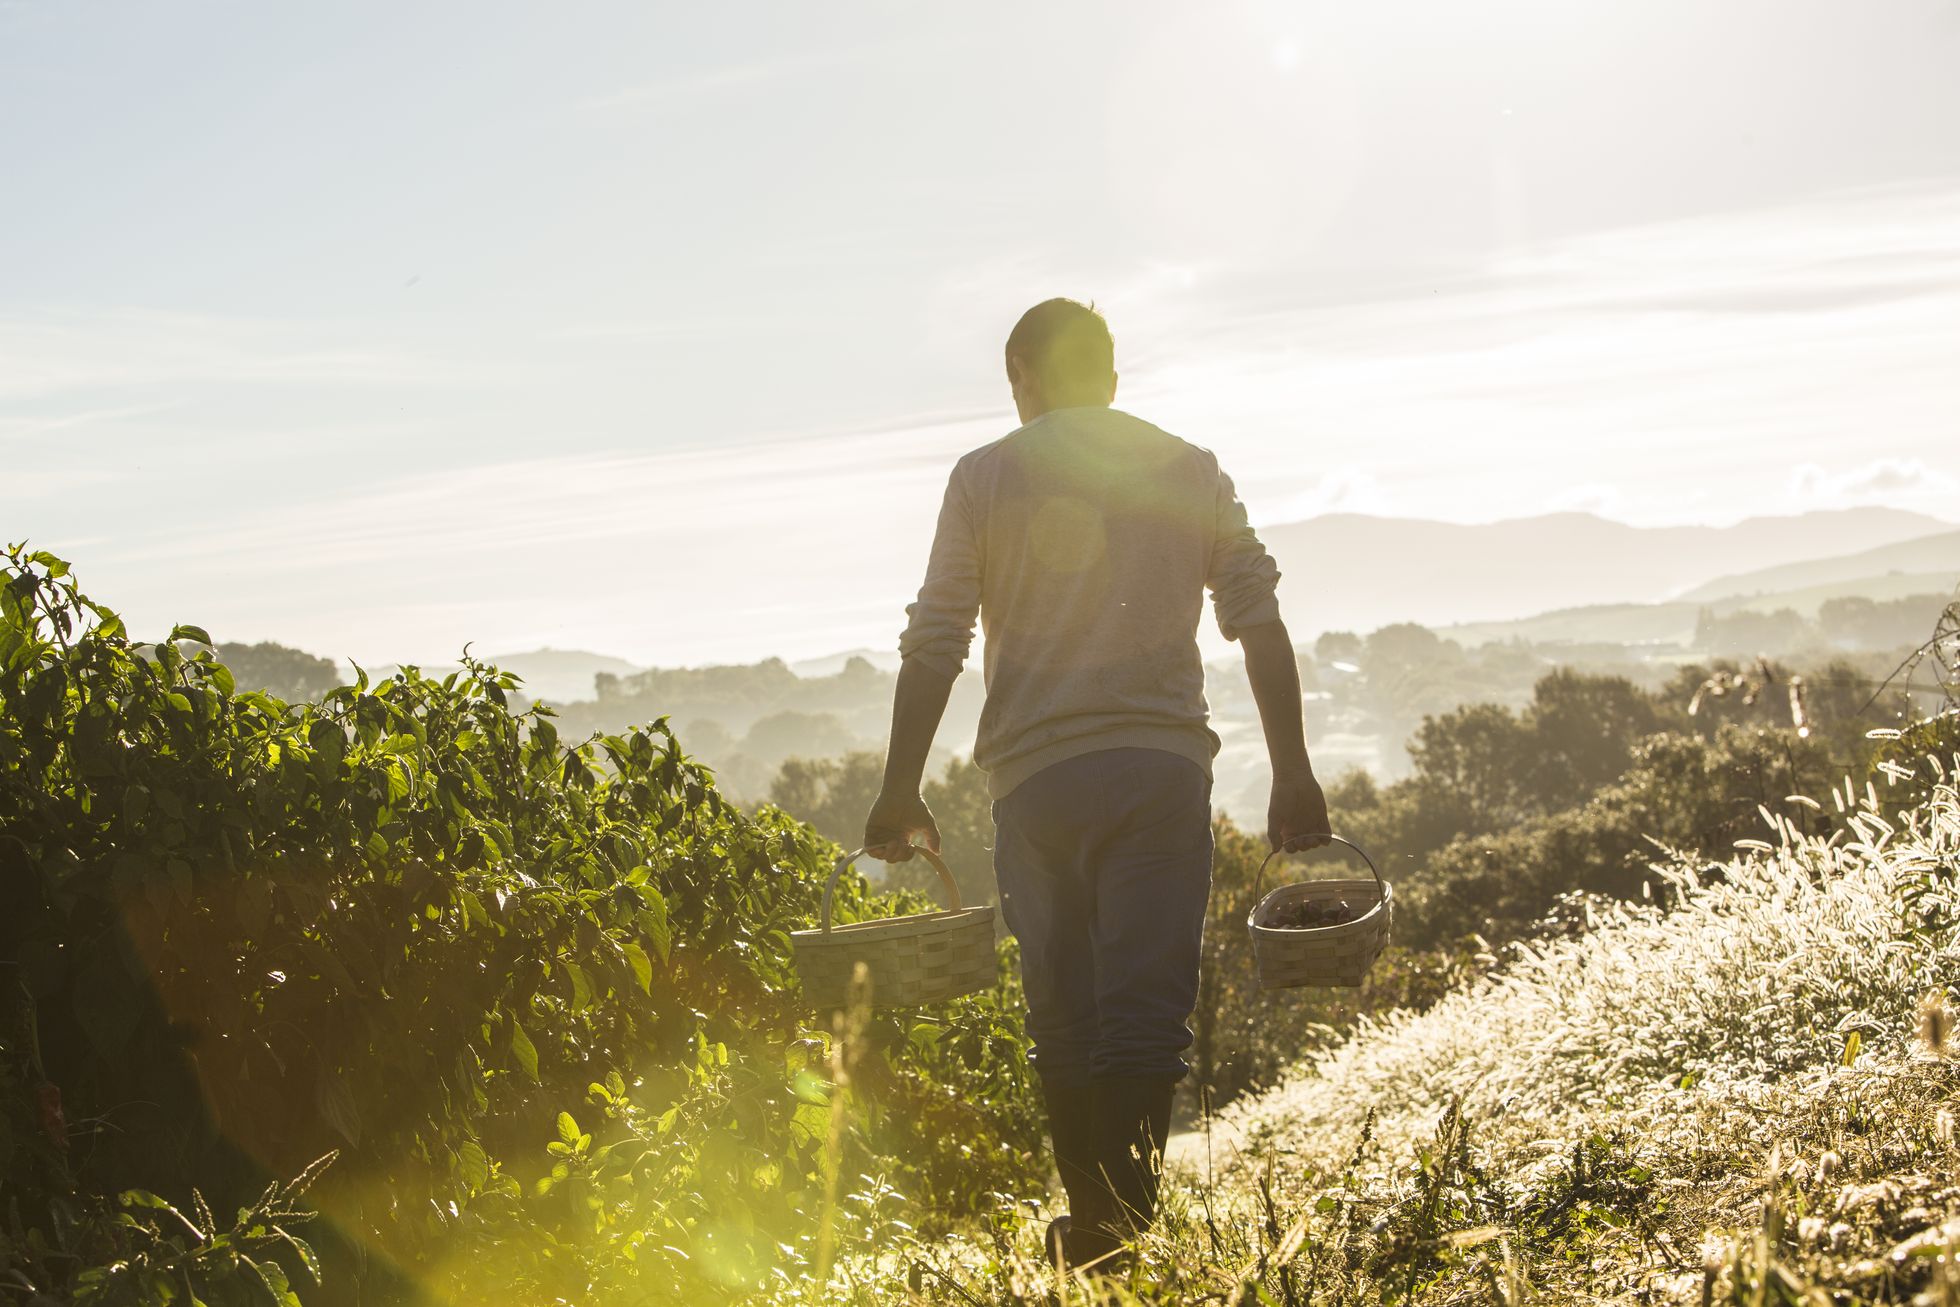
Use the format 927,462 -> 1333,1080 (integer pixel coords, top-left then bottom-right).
864,300 -> 1329,1266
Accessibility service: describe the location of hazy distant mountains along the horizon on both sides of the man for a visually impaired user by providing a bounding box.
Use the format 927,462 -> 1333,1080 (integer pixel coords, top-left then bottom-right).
344,508 -> 1960,703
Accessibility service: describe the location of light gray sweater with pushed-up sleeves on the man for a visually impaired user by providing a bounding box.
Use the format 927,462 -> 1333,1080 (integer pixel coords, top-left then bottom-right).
898,408 -> 1280,798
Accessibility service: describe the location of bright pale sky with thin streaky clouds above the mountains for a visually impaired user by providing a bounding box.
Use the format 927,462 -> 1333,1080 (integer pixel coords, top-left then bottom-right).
0,0 -> 1960,664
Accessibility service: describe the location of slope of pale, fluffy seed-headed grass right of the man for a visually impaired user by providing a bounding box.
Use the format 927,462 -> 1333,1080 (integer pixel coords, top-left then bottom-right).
1160,758 -> 1960,1303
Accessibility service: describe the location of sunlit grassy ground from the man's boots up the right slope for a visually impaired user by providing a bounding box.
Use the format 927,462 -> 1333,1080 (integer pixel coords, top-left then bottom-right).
778,758 -> 1960,1307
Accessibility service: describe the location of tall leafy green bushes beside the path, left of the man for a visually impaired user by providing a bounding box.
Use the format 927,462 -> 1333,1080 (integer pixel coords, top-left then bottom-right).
0,551 -> 1039,1301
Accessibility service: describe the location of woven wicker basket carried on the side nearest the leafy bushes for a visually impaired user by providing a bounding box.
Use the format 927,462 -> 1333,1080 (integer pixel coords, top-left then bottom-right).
790,848 -> 996,1011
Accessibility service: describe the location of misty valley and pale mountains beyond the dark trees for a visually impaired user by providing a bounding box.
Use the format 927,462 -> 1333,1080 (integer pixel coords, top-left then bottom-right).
260,508 -> 1960,815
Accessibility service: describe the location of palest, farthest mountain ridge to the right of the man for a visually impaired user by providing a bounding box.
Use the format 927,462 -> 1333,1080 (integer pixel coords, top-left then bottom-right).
1260,508 -> 1952,637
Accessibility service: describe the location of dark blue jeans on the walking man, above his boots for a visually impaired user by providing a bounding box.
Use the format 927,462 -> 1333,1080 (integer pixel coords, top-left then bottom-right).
994,749 -> 1211,1084
